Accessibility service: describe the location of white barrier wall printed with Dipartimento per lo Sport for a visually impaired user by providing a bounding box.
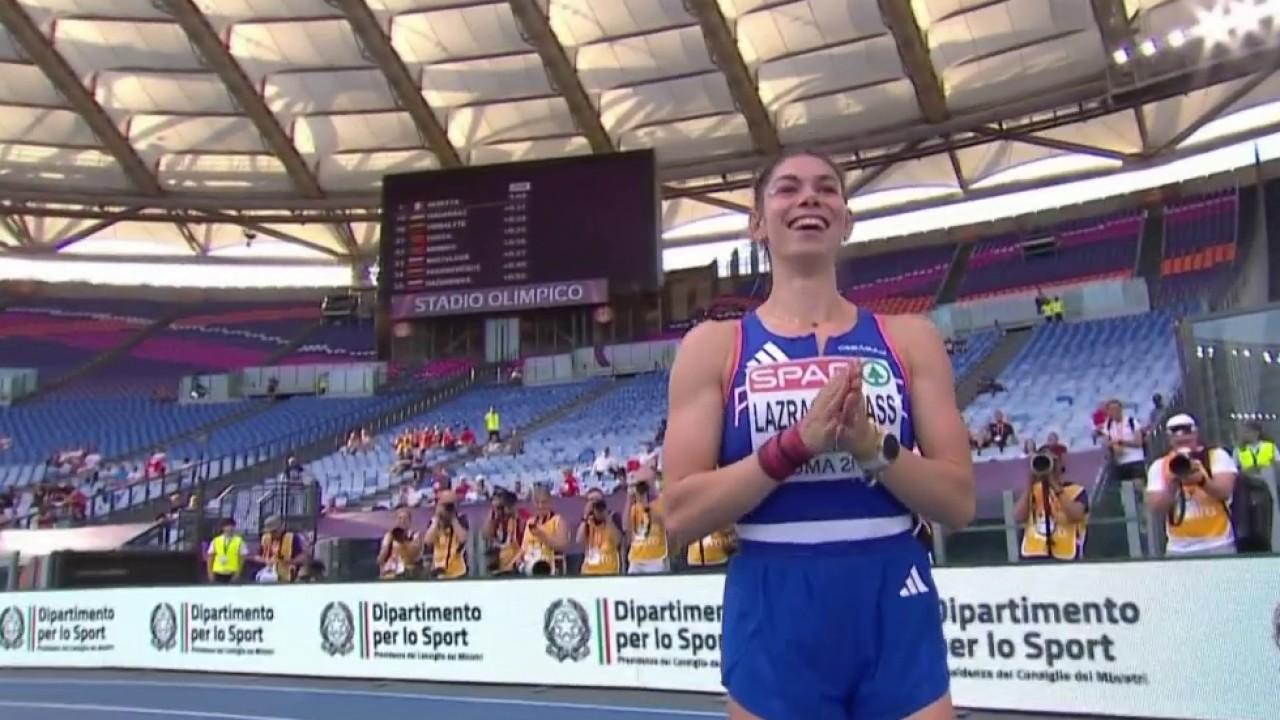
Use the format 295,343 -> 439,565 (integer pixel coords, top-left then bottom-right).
0,557 -> 1280,720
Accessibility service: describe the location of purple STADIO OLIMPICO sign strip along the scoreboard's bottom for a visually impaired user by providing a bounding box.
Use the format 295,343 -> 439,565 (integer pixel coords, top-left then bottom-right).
392,278 -> 609,320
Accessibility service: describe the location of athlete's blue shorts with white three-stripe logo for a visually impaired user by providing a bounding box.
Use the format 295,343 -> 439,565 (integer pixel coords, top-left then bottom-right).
721,534 -> 950,720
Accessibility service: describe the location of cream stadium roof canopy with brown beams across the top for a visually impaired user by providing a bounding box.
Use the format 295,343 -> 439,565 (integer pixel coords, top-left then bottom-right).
0,0 -> 1280,269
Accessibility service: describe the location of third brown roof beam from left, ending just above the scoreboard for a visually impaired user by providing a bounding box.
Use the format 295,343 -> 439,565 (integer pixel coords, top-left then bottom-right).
328,0 -> 462,168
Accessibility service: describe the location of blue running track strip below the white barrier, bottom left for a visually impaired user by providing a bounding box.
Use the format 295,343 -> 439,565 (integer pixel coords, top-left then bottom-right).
0,670 -> 1116,720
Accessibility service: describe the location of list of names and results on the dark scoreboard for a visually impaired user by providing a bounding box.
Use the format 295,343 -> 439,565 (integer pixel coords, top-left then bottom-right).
390,182 -> 538,293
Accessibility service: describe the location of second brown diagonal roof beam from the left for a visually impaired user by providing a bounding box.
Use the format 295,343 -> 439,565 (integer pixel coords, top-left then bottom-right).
162,0 -> 358,256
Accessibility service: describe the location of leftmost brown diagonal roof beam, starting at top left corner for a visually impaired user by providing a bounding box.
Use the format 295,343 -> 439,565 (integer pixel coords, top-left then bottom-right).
0,0 -> 163,195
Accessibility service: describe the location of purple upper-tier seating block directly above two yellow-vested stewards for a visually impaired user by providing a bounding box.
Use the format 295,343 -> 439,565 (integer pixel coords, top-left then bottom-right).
959,211 -> 1142,300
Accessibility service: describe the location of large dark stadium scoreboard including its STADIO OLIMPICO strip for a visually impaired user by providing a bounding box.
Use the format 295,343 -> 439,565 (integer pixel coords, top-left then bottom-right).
378,151 -> 660,319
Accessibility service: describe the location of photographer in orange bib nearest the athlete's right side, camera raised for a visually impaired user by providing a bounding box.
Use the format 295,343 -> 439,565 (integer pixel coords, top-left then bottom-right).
1014,446 -> 1089,561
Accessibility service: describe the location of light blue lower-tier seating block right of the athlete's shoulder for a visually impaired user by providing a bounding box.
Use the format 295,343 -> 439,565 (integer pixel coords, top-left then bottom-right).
964,310 -> 1180,459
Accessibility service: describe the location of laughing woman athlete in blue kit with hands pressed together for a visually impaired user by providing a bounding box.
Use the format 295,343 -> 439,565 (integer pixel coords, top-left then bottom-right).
664,152 -> 974,720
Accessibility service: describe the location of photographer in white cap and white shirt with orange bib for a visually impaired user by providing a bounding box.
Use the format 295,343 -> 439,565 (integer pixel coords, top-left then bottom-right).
1147,414 -> 1239,556
